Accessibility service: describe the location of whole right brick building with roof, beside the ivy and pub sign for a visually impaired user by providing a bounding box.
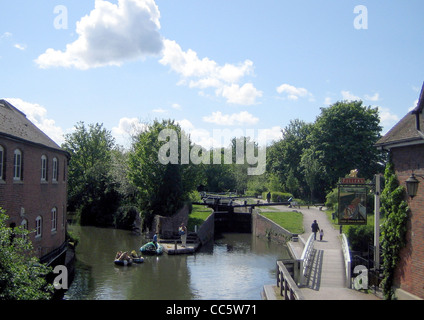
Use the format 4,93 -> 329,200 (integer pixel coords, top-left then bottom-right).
377,86 -> 424,299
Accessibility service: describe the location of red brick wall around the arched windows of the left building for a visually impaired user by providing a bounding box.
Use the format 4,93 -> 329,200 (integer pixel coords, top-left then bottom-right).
0,137 -> 67,257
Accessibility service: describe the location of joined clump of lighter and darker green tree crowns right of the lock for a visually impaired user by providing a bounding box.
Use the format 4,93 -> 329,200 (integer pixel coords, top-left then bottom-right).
267,101 -> 384,202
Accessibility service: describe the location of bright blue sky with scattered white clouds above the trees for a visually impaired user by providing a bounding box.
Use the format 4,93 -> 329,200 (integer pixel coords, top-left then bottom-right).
0,0 -> 424,148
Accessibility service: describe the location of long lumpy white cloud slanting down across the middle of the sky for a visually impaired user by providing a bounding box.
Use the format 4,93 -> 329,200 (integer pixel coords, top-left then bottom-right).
159,40 -> 262,105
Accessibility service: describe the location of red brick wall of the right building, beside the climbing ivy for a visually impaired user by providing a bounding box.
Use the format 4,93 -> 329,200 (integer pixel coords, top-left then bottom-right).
392,145 -> 424,299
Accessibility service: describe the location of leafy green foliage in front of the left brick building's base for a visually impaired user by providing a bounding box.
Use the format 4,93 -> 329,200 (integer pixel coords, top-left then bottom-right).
0,208 -> 53,300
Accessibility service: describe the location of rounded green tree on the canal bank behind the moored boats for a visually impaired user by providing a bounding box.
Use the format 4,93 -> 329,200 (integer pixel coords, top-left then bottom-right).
128,120 -> 202,225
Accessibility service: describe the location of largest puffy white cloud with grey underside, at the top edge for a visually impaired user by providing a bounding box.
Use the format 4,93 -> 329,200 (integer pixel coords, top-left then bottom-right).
36,0 -> 163,70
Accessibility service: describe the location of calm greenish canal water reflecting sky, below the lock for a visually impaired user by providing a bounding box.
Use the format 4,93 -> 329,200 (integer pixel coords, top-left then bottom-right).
64,226 -> 290,300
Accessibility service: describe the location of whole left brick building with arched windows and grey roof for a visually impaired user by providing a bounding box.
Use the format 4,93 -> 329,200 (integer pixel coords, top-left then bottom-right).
0,100 -> 69,263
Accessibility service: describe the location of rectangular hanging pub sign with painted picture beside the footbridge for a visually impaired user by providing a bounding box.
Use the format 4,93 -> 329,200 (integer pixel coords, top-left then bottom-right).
338,177 -> 367,225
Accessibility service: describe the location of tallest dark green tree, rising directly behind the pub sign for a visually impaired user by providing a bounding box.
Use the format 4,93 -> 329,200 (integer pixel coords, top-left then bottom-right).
304,101 -> 383,199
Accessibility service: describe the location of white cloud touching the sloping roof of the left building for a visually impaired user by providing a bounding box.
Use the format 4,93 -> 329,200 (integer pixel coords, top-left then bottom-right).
6,98 -> 64,145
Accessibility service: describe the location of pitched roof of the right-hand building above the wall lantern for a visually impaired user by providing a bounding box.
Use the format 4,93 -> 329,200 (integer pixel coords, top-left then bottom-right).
376,85 -> 424,149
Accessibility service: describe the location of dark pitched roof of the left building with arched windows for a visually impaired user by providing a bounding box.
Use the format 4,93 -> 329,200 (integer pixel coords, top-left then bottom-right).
0,99 -> 65,152
